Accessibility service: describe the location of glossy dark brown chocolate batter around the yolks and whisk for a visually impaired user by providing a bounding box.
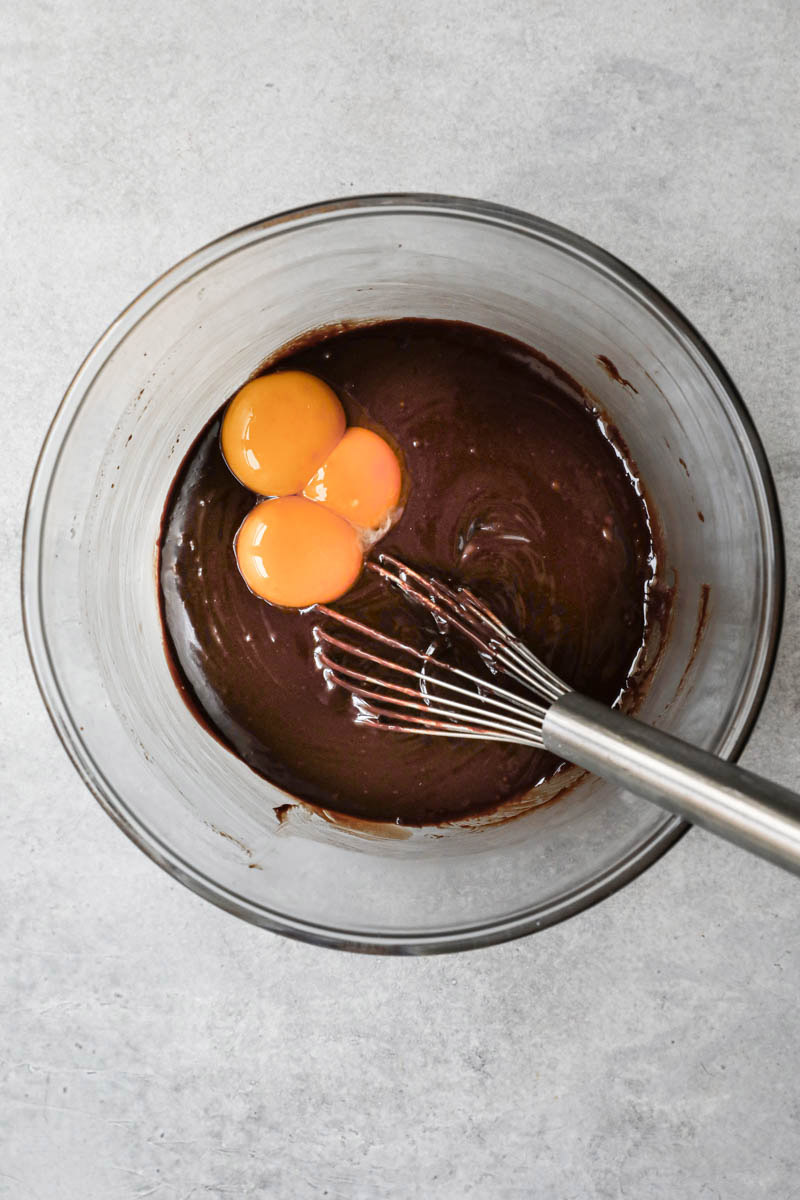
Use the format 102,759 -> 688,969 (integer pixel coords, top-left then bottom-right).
161,320 -> 652,824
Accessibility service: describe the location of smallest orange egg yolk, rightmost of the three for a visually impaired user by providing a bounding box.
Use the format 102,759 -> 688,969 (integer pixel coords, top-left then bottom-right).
303,426 -> 403,529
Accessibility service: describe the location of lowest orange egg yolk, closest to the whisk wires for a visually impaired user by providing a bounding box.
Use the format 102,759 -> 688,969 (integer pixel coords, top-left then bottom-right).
235,496 -> 363,608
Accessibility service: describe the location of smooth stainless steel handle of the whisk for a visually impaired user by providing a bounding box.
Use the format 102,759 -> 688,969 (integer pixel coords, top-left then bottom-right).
542,691 -> 800,875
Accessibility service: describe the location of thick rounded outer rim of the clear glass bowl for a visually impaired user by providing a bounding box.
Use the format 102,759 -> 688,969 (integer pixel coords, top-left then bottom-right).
20,192 -> 786,954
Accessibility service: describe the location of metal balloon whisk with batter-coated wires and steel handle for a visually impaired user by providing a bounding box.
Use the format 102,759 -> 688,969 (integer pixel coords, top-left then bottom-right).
314,554 -> 800,875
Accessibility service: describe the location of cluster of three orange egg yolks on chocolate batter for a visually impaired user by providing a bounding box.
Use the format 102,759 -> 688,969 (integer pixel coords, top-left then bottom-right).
221,371 -> 403,608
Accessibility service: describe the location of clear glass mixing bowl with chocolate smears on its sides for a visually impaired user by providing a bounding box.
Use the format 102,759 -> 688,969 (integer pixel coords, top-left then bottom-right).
23,196 -> 783,954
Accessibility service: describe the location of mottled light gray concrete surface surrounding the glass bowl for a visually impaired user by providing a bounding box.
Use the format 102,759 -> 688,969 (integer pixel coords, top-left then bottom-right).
0,0 -> 800,1200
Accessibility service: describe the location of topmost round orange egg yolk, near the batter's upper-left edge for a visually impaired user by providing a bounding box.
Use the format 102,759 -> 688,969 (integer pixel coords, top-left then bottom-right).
222,371 -> 347,496
